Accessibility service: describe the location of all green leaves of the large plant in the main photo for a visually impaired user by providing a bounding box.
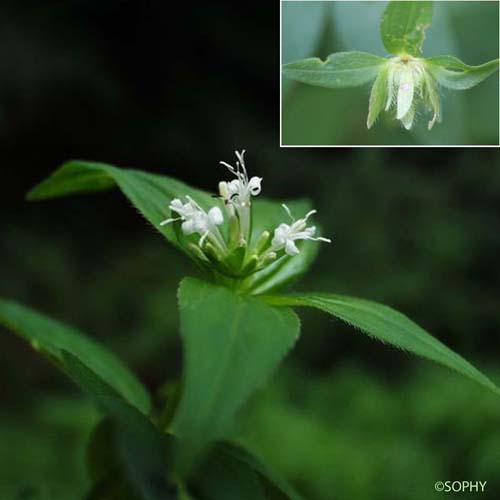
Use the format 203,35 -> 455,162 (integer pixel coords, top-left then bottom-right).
0,157 -> 499,499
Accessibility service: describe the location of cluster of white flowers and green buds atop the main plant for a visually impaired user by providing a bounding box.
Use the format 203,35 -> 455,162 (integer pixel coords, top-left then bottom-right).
160,150 -> 331,277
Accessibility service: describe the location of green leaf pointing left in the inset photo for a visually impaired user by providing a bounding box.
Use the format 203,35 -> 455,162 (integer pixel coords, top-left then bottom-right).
283,52 -> 387,88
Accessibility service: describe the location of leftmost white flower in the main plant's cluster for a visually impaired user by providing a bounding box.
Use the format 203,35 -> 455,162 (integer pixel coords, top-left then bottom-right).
160,196 -> 225,246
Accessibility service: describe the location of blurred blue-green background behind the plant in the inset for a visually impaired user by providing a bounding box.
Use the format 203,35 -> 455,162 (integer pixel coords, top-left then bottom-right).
282,1 -> 499,145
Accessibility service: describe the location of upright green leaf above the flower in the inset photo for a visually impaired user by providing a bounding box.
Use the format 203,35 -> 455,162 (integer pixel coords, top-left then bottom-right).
380,1 -> 432,57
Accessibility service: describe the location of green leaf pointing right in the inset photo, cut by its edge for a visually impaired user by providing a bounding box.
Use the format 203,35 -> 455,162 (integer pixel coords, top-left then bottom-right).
425,56 -> 498,90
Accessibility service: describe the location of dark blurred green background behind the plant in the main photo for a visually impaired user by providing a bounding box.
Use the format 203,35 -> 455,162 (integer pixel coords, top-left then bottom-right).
0,0 -> 500,500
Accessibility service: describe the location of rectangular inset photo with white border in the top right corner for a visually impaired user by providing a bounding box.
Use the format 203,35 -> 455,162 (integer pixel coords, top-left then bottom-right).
280,0 -> 500,147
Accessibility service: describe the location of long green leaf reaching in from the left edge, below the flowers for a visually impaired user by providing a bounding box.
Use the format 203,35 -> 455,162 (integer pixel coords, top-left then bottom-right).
0,299 -> 151,413
